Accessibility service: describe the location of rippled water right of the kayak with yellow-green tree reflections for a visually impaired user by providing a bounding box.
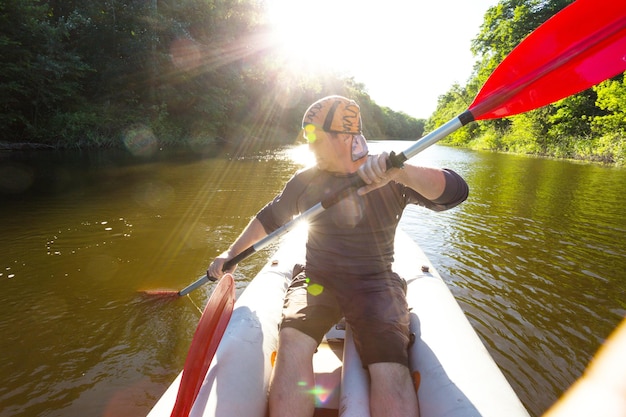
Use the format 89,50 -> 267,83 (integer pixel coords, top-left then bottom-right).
404,144 -> 626,415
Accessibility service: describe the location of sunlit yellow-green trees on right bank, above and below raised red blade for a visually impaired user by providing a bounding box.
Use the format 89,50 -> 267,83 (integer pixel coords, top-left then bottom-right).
426,0 -> 626,163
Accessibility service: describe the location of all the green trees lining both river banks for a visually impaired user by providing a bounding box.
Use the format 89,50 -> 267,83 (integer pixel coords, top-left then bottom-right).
6,0 -> 626,163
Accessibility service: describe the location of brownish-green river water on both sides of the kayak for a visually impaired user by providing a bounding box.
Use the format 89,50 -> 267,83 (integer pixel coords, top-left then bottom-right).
0,142 -> 626,417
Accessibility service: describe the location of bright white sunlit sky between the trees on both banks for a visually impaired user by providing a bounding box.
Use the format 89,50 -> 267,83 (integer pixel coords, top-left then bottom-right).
267,0 -> 498,118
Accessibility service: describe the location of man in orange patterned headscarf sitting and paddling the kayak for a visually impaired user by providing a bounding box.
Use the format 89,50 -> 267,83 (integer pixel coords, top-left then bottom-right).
207,96 -> 468,417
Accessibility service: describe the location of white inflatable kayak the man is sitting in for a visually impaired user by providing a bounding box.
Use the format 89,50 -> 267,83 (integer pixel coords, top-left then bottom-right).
148,230 -> 529,417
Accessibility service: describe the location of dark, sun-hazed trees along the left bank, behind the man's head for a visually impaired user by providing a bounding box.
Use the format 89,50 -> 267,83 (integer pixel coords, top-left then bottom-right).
0,0 -> 424,147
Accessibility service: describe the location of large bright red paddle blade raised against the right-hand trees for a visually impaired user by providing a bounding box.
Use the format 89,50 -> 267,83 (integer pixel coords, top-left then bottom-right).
469,0 -> 626,120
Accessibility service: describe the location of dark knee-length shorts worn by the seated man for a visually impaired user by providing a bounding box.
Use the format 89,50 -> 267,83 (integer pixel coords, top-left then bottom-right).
281,264 -> 410,366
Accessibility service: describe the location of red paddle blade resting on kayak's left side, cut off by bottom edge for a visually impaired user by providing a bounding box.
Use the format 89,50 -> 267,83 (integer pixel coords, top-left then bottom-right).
171,274 -> 235,417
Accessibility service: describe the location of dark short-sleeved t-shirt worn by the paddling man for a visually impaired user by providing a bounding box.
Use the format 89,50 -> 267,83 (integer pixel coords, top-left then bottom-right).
257,167 -> 468,276
